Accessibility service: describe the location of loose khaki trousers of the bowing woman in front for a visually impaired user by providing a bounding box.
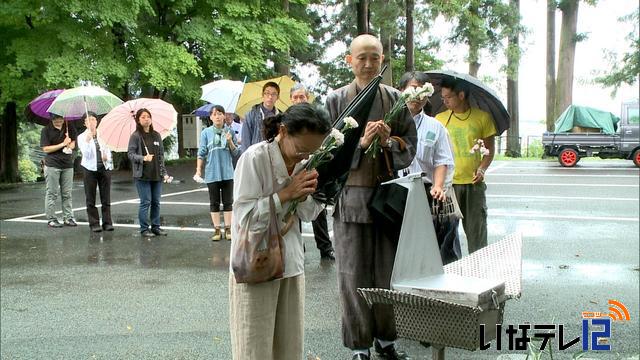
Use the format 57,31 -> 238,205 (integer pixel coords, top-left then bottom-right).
229,273 -> 304,360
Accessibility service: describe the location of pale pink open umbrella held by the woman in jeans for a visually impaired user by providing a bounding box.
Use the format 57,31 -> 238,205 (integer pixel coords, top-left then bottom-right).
97,98 -> 178,152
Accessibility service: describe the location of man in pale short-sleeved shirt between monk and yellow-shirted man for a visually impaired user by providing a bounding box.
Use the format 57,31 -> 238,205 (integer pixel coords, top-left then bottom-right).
398,71 -> 461,264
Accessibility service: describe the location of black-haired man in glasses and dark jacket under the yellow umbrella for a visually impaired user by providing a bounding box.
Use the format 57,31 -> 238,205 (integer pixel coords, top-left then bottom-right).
240,81 -> 280,151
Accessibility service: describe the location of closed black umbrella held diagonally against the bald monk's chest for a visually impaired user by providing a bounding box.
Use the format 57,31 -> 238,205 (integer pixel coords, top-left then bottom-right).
313,66 -> 387,204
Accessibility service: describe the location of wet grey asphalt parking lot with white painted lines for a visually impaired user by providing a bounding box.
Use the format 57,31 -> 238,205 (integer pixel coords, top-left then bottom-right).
0,160 -> 640,359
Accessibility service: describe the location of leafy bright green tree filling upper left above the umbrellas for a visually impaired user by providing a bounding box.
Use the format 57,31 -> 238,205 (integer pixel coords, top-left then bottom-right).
0,0 -> 318,180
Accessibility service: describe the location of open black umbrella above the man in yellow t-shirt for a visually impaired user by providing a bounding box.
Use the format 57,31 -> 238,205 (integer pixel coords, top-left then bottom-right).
425,70 -> 511,136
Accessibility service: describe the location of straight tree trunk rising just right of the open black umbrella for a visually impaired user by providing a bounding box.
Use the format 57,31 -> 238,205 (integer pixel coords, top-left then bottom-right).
506,0 -> 521,157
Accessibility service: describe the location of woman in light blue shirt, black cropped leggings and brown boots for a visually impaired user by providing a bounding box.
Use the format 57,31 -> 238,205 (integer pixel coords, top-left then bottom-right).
194,105 -> 240,241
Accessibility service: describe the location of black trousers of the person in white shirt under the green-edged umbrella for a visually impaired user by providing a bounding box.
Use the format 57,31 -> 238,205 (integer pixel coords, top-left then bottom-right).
83,167 -> 113,227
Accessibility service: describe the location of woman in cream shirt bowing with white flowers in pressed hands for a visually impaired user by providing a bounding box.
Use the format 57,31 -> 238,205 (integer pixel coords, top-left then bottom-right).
229,104 -> 331,360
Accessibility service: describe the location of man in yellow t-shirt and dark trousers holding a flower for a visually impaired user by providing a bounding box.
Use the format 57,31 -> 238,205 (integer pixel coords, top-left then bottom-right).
436,78 -> 496,254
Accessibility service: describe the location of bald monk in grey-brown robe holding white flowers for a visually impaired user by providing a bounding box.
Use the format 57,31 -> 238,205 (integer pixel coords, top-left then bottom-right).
326,35 -> 417,360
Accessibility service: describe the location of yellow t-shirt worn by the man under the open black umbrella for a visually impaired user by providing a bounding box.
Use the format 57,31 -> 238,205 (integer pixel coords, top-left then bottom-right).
436,108 -> 496,184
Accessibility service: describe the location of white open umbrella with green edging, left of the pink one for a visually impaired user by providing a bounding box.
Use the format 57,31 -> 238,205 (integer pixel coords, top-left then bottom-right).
47,86 -> 123,117
